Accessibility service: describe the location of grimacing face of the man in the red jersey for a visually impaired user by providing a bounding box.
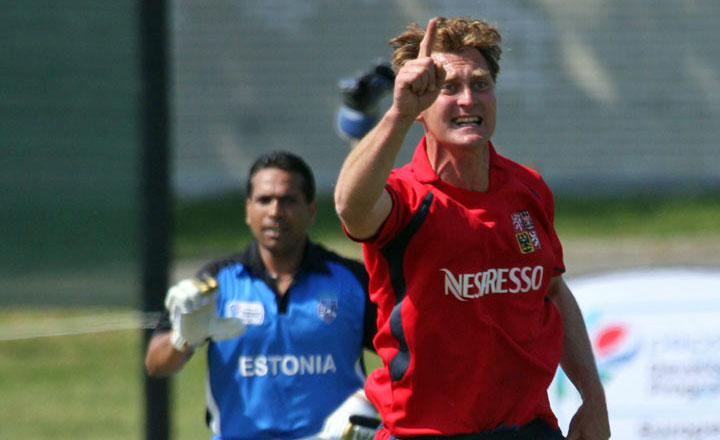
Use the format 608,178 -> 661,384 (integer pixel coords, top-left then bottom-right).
419,49 -> 497,147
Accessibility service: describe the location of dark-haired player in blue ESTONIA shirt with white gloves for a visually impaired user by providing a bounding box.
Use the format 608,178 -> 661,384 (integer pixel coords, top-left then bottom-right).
145,152 -> 376,440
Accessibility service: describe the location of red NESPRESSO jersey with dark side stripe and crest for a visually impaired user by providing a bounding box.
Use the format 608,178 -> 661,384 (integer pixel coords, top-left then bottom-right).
363,139 -> 564,439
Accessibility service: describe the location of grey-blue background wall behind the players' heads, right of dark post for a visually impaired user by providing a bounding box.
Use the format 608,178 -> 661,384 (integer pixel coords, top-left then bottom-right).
173,0 -> 720,195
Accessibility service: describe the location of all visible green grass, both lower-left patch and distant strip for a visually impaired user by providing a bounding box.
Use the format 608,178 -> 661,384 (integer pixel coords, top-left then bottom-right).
0,195 -> 720,440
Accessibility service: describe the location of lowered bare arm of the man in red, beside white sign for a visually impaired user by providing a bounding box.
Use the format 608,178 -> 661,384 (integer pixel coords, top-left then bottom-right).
548,276 -> 610,440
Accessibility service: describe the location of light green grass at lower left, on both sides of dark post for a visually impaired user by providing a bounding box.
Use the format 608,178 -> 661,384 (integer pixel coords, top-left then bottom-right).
0,309 -> 209,440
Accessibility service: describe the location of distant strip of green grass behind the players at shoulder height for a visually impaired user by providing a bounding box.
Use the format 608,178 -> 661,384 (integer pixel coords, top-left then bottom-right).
175,193 -> 720,258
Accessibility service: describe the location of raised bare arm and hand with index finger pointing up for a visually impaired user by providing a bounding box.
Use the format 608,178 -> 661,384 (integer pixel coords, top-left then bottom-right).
335,19 -> 445,239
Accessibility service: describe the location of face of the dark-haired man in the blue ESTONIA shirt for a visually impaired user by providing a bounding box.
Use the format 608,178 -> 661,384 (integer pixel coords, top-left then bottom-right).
245,168 -> 317,255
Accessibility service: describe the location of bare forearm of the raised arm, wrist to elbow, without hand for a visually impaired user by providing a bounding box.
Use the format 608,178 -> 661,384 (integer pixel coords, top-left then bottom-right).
335,109 -> 414,238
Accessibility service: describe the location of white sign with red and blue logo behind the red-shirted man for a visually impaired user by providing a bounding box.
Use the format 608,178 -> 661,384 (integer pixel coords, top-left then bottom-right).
549,269 -> 720,440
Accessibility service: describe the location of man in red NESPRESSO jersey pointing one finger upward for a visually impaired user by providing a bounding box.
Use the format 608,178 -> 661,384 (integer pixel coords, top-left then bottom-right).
335,17 -> 610,440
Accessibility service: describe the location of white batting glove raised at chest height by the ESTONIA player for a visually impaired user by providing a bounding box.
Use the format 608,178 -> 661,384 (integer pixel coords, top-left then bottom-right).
165,277 -> 245,351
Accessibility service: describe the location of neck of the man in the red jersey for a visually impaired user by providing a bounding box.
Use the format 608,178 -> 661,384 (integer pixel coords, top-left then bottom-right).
426,139 -> 490,192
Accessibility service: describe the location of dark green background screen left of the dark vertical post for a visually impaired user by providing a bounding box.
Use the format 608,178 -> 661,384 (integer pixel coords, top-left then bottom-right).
0,1 -> 140,304
